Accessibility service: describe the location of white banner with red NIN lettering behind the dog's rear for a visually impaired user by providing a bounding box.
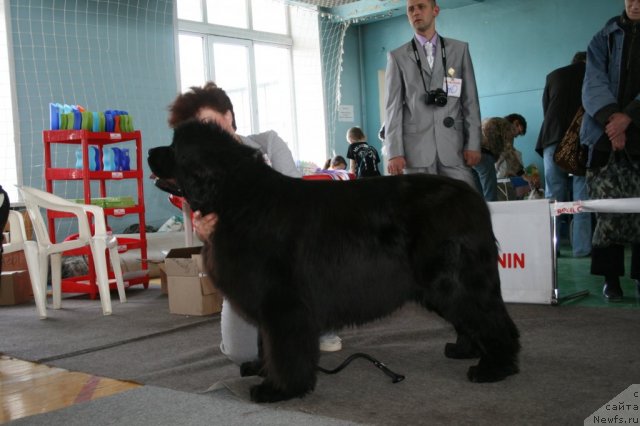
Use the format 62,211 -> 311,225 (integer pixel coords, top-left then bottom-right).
488,199 -> 554,304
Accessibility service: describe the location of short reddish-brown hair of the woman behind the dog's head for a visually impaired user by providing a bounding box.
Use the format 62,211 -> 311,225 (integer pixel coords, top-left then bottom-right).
169,81 -> 237,130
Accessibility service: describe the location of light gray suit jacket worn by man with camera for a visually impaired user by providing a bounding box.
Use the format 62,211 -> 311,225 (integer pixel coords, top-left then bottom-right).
384,38 -> 482,167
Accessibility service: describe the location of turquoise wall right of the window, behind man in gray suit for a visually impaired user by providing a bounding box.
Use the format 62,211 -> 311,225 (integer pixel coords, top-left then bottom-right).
336,0 -> 624,175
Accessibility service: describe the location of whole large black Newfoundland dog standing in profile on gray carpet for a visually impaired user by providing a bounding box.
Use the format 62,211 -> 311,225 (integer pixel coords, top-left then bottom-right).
148,121 -> 520,402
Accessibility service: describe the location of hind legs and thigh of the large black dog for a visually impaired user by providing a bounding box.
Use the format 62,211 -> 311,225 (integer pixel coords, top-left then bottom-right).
423,243 -> 520,382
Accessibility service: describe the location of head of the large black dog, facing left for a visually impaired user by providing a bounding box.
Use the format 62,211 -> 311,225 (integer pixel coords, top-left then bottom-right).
147,120 -> 264,214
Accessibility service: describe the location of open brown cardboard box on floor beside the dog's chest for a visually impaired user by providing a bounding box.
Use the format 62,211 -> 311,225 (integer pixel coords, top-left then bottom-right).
164,247 -> 222,315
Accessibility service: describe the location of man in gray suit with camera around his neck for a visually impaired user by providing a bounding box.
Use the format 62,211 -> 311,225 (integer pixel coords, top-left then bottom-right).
384,0 -> 482,188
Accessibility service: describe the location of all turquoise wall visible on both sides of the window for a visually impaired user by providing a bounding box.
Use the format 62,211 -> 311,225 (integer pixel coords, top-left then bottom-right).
10,0 -> 624,236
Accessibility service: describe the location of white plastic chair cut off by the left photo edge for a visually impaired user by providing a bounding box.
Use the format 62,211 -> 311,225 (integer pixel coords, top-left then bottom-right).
2,210 -> 47,319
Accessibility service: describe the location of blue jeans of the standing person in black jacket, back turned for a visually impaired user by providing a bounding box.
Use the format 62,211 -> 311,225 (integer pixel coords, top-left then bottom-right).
543,144 -> 591,257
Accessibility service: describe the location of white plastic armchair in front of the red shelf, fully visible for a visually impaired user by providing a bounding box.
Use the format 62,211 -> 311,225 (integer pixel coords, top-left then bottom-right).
18,186 -> 127,315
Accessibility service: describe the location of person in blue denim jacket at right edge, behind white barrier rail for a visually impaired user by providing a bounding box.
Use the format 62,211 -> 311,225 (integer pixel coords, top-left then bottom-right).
580,0 -> 640,301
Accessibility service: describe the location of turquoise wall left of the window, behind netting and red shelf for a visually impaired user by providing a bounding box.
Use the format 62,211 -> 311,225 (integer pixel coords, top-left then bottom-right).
10,0 -> 179,231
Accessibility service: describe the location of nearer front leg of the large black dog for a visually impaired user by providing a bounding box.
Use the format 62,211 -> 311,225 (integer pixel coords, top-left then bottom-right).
251,305 -> 320,402
